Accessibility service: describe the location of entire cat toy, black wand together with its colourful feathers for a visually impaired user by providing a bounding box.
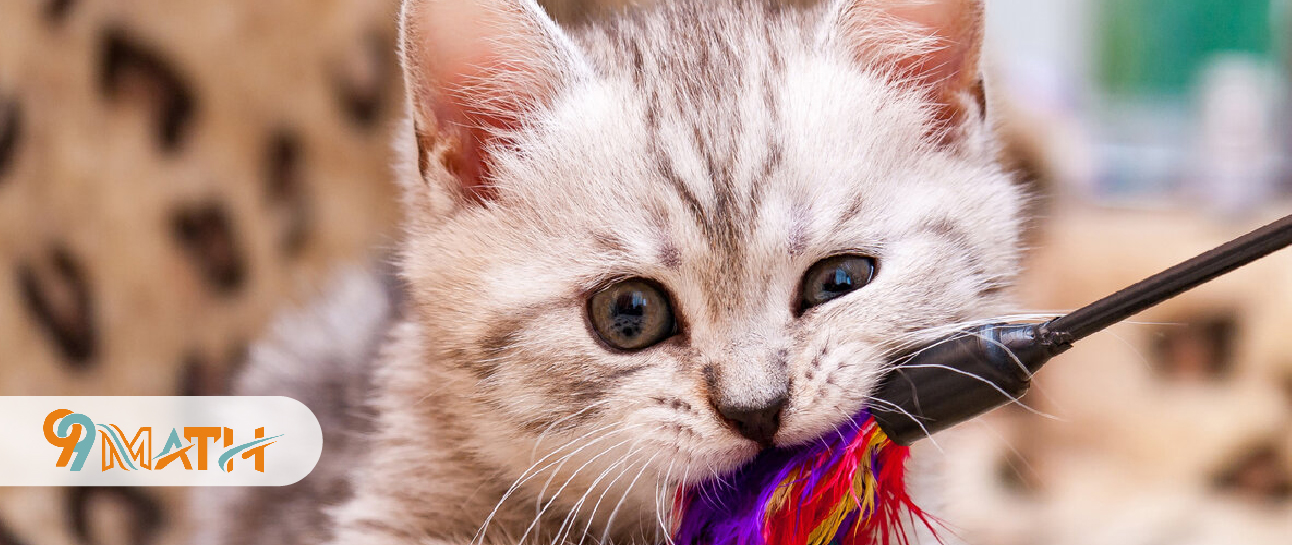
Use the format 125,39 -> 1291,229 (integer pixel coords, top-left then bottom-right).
671,216 -> 1292,545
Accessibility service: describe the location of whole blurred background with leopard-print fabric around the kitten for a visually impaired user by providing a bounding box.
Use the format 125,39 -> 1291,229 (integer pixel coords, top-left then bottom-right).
0,0 -> 1292,545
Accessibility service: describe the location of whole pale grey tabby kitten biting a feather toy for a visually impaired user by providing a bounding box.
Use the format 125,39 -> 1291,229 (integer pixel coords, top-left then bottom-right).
198,0 -> 1022,545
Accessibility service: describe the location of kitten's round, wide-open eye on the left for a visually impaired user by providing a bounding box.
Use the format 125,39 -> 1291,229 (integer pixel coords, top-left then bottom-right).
588,280 -> 677,350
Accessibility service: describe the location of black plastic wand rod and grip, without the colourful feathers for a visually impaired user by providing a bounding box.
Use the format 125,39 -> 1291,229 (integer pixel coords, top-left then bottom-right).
870,211 -> 1292,444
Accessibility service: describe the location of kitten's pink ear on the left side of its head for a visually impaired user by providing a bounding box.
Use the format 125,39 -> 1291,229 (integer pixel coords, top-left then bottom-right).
401,0 -> 580,203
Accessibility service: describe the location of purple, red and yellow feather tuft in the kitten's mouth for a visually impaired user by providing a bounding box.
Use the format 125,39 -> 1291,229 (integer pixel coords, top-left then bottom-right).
673,411 -> 935,545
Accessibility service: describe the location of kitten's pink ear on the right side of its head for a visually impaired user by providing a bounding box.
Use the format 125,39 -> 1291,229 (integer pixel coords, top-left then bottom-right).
829,0 -> 987,141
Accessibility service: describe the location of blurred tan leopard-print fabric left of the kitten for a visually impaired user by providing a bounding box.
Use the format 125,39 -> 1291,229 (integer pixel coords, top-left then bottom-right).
0,0 -> 402,545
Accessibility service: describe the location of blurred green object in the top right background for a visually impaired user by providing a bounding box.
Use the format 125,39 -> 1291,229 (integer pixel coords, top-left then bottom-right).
1099,0 -> 1276,97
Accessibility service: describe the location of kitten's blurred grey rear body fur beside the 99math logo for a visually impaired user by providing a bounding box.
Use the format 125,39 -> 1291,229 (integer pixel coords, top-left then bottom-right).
193,270 -> 399,545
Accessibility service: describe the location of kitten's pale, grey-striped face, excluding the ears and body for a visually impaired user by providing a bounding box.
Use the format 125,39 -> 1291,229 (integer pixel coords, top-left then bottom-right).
406,0 -> 1019,479
